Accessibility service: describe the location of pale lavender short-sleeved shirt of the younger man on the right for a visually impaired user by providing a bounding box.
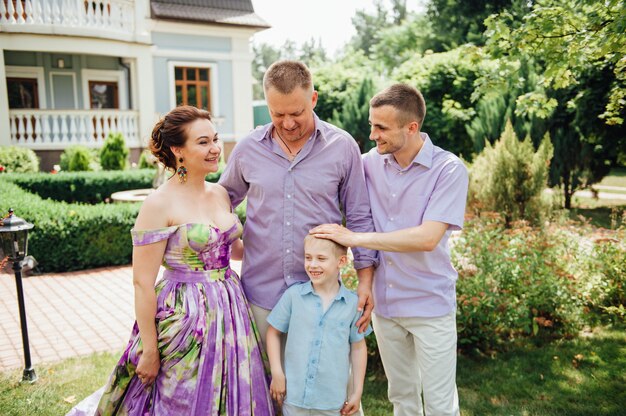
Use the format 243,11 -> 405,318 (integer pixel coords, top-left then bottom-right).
363,133 -> 468,318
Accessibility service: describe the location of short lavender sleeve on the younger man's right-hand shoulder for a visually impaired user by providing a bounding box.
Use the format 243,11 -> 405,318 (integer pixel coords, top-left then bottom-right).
422,158 -> 469,230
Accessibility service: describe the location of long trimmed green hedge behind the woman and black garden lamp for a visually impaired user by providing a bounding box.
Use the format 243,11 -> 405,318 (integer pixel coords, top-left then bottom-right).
0,167 -> 241,272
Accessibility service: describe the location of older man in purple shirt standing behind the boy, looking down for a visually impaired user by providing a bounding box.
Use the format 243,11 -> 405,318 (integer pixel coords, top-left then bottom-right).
219,61 -> 377,345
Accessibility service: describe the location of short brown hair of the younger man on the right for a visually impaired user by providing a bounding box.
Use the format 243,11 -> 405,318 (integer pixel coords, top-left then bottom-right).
370,84 -> 426,129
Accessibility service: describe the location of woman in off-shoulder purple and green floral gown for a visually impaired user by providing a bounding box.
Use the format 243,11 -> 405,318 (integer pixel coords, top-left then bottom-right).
70,106 -> 273,416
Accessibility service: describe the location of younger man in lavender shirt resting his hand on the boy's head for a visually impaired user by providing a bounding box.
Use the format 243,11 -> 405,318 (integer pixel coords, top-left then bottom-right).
311,84 -> 468,416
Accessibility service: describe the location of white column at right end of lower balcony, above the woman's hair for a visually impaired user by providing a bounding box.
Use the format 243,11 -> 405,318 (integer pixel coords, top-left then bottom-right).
131,46 -> 156,147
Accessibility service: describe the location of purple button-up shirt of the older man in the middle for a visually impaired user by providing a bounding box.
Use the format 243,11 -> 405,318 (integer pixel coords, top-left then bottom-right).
219,116 -> 377,309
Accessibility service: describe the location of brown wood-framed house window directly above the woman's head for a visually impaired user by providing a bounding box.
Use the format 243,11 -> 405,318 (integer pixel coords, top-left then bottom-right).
174,66 -> 211,111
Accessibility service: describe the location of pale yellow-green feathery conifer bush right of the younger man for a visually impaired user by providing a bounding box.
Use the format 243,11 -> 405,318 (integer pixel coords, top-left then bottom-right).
470,122 -> 553,226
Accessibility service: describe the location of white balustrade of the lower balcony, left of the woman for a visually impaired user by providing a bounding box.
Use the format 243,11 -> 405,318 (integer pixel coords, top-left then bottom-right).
9,109 -> 140,150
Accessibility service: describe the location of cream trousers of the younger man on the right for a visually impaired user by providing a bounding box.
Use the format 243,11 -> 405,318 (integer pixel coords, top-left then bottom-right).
372,312 -> 460,416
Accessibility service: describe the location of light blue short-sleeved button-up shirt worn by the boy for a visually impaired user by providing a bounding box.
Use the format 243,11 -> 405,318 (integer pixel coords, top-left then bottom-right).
267,281 -> 372,410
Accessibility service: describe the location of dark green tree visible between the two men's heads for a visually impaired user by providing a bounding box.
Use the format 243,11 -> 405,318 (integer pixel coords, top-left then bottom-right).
330,78 -> 376,153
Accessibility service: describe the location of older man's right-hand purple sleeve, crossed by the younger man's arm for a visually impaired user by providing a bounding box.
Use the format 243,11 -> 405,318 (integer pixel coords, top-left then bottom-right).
339,138 -> 378,269
